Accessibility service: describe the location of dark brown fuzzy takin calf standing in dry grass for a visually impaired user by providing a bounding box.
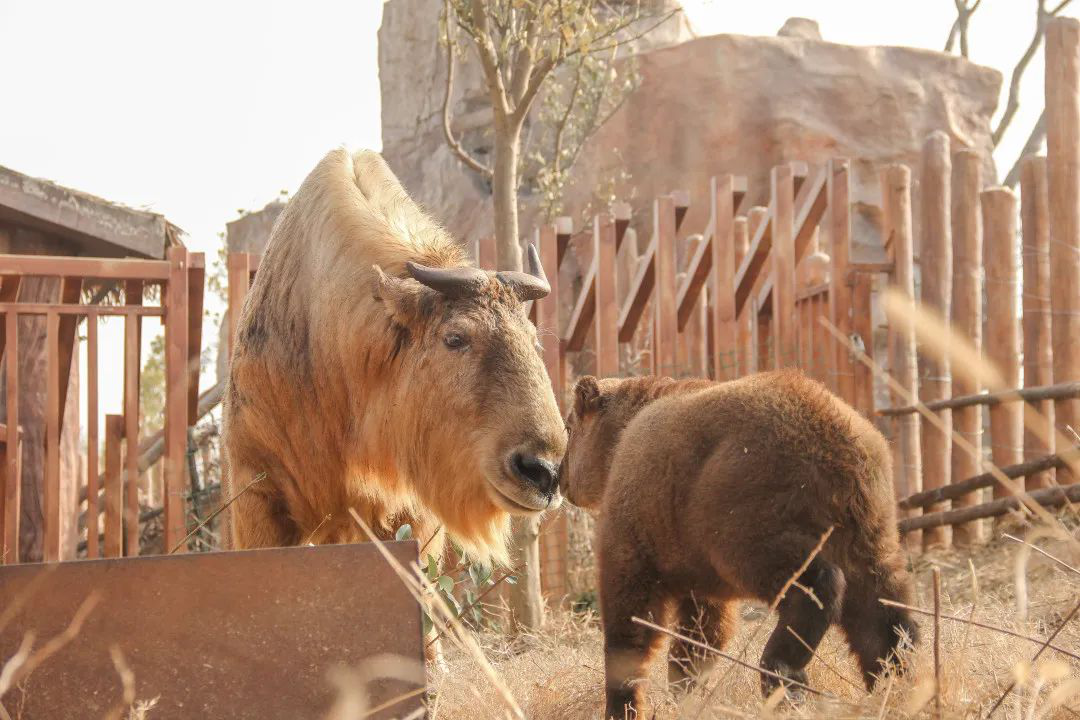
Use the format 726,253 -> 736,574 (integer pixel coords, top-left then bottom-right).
561,371 -> 916,718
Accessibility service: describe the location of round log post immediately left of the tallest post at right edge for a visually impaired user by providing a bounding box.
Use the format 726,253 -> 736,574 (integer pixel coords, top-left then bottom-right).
1020,155 -> 1055,490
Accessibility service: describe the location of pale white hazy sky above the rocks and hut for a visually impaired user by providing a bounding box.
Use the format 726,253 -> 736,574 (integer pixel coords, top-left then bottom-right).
0,0 -> 1042,427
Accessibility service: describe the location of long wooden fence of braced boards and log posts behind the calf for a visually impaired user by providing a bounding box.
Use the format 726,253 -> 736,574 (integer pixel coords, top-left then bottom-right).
200,21 -> 1080,597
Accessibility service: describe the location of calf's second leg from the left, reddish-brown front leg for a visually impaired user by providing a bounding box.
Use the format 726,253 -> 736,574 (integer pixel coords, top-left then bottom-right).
667,597 -> 738,692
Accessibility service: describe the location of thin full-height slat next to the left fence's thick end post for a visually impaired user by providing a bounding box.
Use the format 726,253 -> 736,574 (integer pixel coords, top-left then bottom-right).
124,280 -> 143,557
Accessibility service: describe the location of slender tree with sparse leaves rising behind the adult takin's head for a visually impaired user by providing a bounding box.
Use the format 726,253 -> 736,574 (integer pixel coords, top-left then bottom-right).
440,0 -> 679,628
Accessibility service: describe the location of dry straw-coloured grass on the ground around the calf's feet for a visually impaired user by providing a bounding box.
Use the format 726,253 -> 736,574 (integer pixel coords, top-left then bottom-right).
430,518 -> 1080,720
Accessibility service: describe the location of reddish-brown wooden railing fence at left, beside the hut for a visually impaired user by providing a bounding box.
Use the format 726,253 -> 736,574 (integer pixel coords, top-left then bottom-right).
0,247 -> 205,562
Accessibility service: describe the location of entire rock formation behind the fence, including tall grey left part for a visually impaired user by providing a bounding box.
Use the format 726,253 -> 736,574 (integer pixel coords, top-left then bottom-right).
379,9 -> 1001,267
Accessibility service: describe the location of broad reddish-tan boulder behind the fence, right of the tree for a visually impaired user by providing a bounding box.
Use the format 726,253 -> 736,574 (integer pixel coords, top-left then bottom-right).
571,35 -> 1001,264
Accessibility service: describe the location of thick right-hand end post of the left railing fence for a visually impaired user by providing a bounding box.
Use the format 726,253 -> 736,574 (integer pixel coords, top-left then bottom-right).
164,247 -> 191,552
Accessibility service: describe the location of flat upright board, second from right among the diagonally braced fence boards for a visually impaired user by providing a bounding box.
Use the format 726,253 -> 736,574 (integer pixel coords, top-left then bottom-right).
769,164 -> 798,369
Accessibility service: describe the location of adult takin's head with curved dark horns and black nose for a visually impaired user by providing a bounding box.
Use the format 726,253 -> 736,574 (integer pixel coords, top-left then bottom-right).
375,247 -> 566,530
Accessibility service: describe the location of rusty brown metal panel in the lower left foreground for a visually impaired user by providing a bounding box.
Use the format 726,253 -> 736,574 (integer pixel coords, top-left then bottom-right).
0,541 -> 423,720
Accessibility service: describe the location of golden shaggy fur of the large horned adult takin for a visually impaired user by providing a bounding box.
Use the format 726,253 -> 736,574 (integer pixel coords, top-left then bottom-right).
224,150 -> 565,560
